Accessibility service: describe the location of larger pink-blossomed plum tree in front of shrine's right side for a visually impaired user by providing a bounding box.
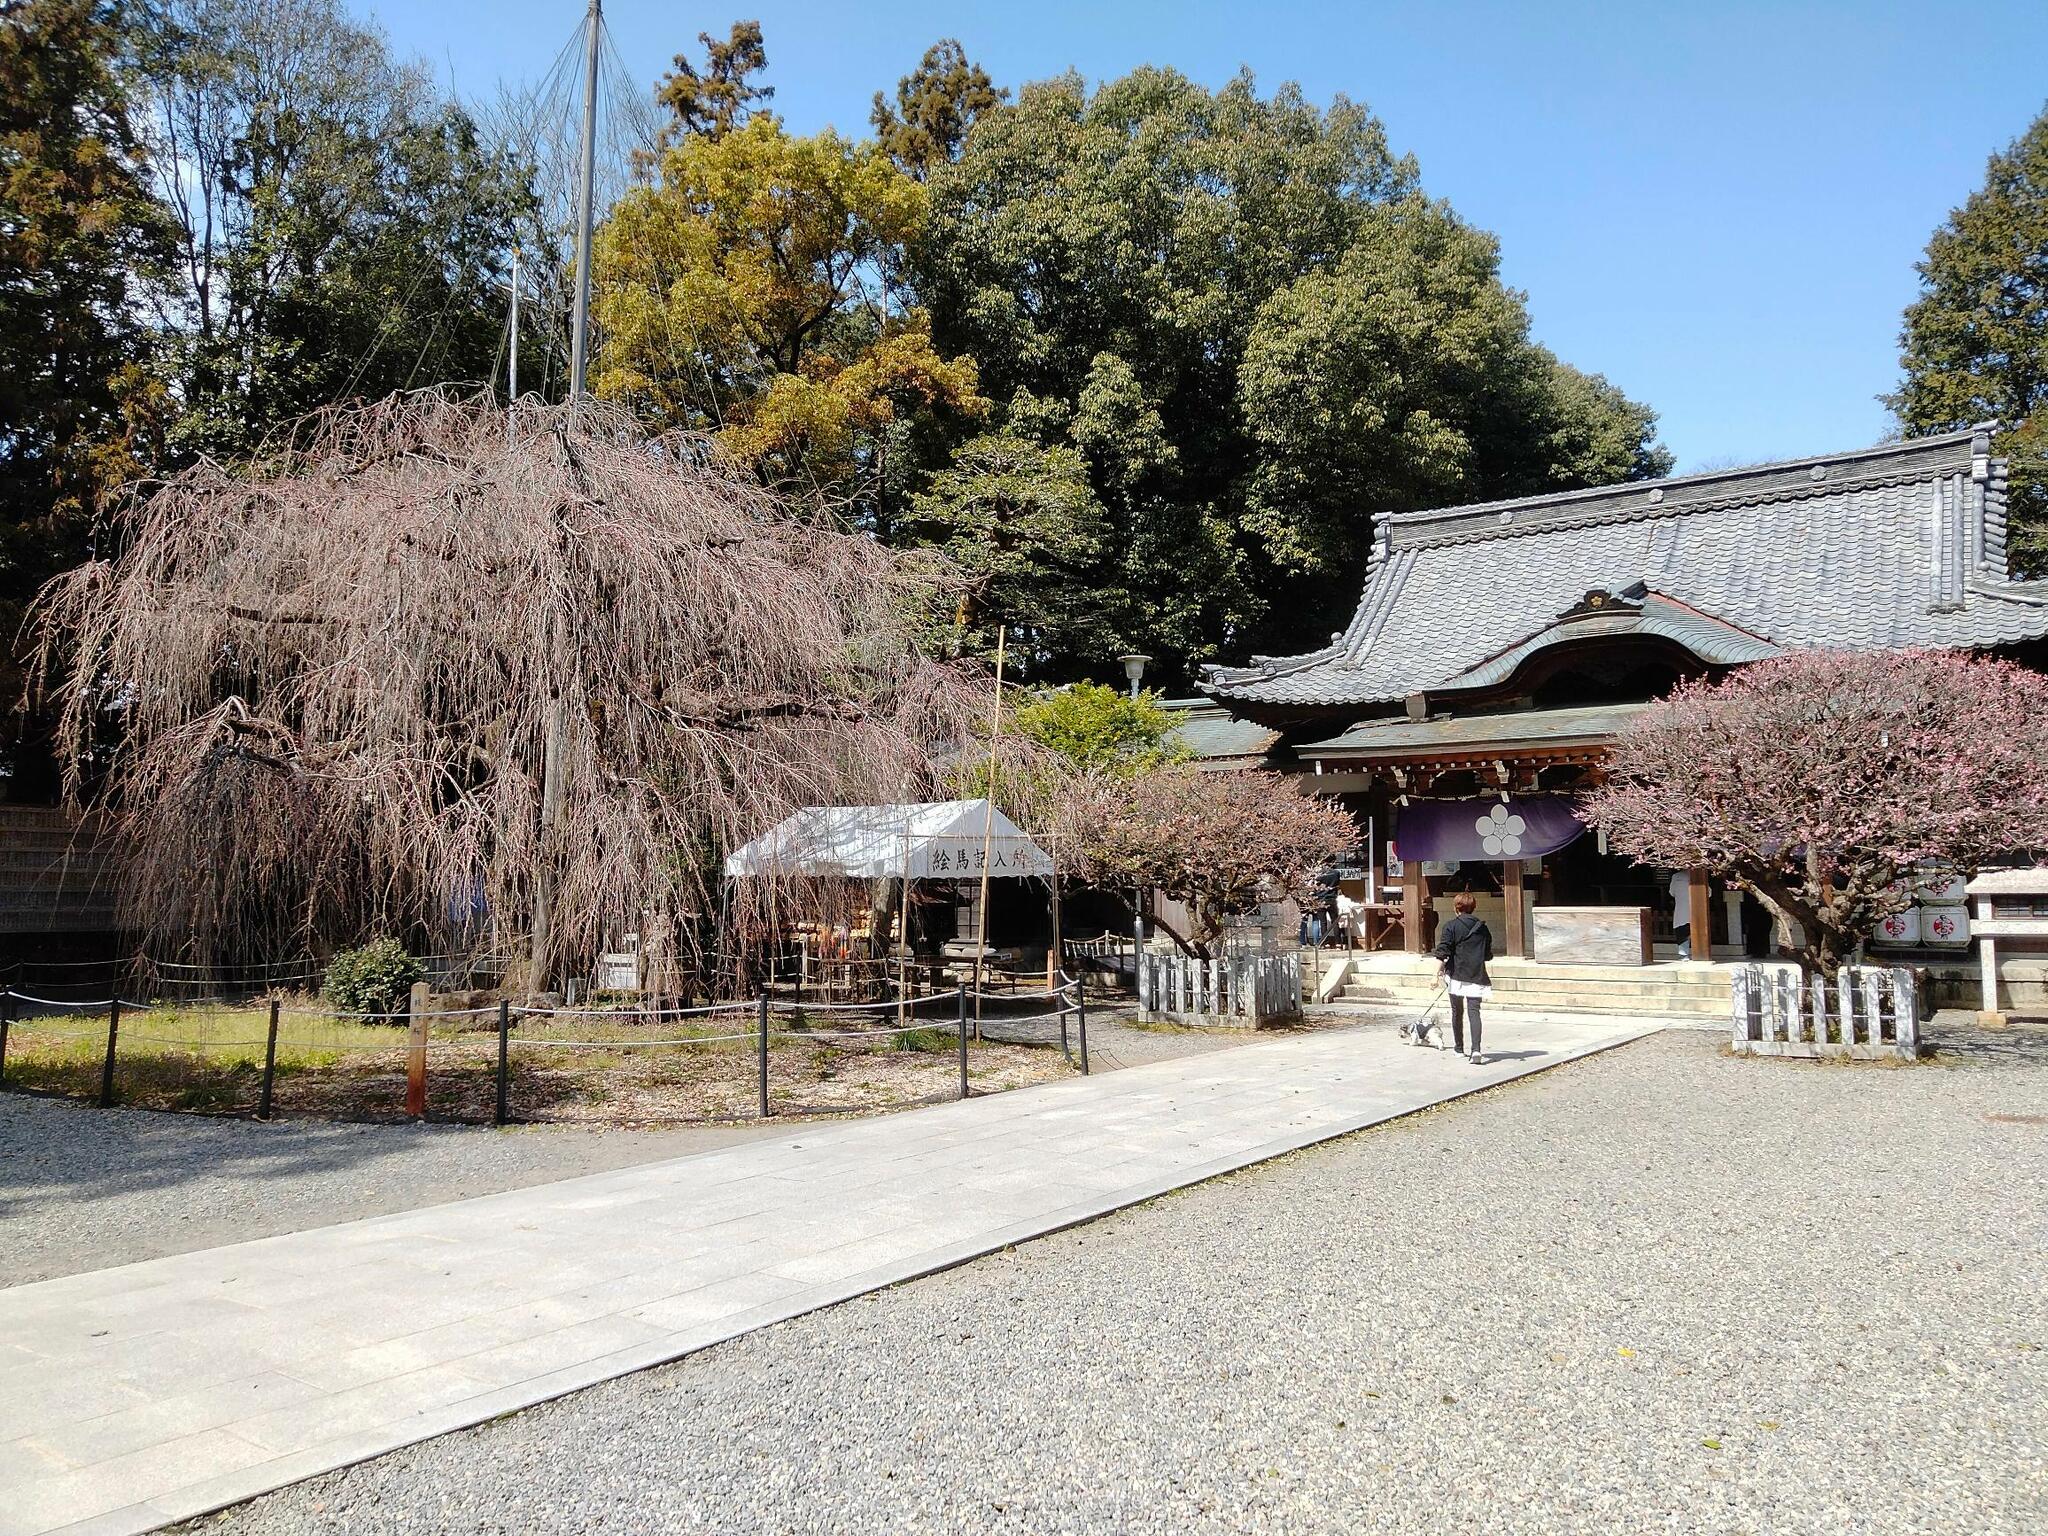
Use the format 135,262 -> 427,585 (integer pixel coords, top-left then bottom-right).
1583,651 -> 2048,977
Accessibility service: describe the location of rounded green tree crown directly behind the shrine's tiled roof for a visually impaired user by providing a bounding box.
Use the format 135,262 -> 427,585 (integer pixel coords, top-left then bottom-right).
1237,195 -> 1669,612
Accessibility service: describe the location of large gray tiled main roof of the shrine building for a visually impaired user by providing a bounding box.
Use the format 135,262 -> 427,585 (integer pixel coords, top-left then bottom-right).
1202,428 -> 2048,711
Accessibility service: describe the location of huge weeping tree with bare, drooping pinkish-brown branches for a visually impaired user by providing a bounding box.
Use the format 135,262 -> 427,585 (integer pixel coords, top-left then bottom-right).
35,393 -> 979,991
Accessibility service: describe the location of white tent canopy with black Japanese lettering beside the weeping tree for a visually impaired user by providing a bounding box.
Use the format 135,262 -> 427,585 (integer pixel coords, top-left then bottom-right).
725,801 -> 1053,881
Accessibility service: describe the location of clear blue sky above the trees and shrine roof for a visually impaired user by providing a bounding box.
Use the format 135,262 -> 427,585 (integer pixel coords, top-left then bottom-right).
350,0 -> 2048,469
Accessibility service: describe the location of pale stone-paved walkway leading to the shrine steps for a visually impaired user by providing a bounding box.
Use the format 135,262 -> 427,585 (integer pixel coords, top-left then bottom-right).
0,1018 -> 1659,1536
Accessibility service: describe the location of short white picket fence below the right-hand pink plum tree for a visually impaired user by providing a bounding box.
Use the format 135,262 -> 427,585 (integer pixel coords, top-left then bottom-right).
1731,965 -> 1919,1059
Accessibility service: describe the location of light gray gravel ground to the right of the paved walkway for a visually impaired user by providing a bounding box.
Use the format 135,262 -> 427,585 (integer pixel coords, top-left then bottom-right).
184,1032 -> 2048,1536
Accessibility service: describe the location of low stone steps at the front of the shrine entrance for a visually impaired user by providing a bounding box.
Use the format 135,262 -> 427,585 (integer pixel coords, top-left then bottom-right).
1333,954 -> 1731,1024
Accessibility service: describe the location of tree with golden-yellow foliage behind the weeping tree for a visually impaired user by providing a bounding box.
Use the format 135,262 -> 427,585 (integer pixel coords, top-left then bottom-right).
592,113 -> 985,530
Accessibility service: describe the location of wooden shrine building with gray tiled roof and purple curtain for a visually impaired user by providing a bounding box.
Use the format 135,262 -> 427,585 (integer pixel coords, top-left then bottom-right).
1190,428 -> 2048,987
